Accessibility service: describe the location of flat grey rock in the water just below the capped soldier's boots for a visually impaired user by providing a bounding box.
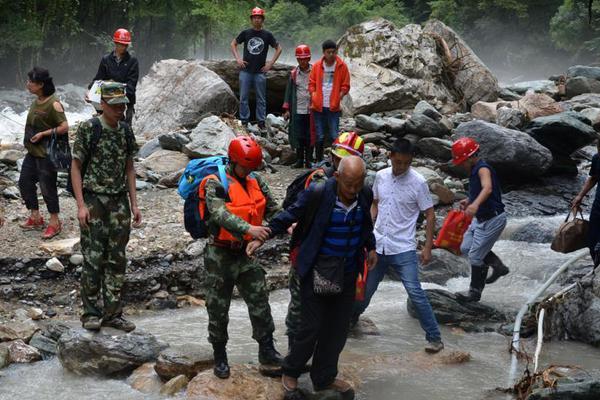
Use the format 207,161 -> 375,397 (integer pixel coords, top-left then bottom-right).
58,329 -> 167,376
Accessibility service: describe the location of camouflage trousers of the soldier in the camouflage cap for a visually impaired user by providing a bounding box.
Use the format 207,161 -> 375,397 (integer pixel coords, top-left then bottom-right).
81,193 -> 131,321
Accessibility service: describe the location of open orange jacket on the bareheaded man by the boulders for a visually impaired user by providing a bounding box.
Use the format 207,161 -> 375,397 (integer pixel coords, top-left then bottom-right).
308,56 -> 350,112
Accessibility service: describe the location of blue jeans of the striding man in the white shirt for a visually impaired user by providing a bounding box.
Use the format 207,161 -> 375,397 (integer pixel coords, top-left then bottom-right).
354,250 -> 442,342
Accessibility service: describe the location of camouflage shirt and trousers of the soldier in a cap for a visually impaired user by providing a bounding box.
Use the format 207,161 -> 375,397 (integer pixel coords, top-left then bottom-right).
73,118 -> 137,322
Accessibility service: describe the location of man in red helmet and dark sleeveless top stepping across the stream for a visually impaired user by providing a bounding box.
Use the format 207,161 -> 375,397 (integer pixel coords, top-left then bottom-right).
452,137 -> 509,302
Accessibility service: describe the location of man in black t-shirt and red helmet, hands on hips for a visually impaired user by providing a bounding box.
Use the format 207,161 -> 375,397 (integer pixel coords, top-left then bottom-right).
231,7 -> 281,129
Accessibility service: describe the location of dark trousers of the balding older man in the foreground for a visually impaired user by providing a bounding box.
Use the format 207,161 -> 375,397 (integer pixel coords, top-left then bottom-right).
283,271 -> 357,390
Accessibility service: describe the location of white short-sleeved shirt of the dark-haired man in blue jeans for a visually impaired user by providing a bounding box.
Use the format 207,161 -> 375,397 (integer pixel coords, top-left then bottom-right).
373,167 -> 433,255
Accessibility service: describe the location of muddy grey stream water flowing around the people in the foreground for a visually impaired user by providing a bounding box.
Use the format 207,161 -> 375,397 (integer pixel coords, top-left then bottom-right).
0,234 -> 600,400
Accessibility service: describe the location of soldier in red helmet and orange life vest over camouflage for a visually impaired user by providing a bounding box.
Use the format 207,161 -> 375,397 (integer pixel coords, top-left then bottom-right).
200,136 -> 282,379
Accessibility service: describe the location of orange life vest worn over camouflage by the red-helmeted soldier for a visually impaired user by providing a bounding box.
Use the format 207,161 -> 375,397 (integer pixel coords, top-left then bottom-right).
198,174 -> 267,242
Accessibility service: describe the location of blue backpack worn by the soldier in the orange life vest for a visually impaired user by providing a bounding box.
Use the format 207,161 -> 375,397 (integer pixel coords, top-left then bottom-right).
177,156 -> 229,239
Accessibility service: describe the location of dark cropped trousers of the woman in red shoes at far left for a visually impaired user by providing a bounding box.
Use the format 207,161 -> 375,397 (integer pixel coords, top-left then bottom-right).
19,154 -> 60,214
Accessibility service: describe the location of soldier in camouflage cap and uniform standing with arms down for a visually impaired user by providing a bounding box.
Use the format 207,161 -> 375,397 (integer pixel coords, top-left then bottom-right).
71,82 -> 142,332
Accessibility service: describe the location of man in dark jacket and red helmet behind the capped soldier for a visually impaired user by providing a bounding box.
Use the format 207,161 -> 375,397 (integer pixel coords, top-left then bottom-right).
86,28 -> 140,126
